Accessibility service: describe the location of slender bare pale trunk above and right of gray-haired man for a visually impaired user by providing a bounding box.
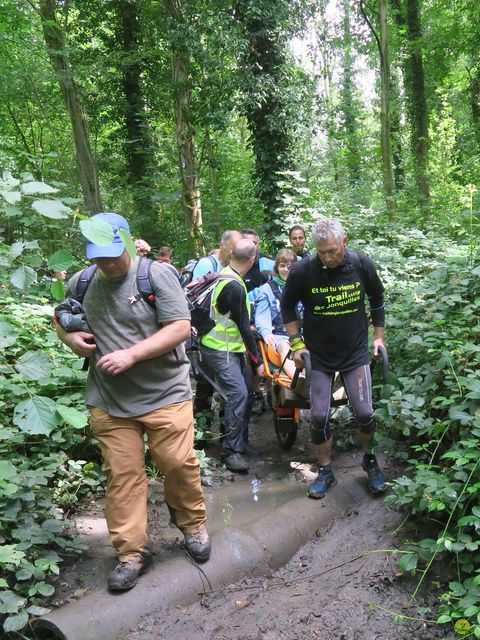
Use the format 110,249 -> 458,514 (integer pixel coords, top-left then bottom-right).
379,0 -> 397,221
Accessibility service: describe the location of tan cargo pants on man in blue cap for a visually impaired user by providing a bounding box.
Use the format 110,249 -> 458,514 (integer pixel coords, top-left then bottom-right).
90,400 -> 206,562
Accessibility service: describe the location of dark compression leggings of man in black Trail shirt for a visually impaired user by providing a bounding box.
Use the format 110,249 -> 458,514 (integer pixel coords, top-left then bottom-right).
310,364 -> 375,444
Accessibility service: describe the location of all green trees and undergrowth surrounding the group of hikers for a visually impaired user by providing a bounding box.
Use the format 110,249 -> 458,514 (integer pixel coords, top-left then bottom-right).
0,0 -> 480,638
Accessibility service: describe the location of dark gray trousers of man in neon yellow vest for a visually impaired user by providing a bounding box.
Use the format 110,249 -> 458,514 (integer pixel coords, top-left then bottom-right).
200,345 -> 253,456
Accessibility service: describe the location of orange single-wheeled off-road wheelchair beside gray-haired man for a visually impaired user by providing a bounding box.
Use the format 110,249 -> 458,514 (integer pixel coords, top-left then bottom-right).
259,340 -> 388,449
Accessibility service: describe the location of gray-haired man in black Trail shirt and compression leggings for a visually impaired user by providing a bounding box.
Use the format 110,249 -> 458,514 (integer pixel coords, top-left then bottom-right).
281,218 -> 386,498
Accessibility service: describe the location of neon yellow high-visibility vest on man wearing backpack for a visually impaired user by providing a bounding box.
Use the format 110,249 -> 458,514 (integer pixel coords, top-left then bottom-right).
200,267 -> 250,353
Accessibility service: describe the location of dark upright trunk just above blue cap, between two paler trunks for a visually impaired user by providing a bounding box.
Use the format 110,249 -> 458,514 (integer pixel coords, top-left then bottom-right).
115,0 -> 154,235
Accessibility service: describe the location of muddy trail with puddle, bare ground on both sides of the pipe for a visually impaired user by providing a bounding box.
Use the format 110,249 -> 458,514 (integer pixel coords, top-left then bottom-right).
57,411 -> 449,640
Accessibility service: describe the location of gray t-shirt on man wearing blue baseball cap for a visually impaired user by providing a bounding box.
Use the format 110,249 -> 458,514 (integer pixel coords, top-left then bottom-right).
67,259 -> 192,418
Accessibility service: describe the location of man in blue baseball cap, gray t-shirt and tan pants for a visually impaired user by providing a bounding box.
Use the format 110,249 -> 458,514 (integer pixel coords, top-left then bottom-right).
57,213 -> 210,591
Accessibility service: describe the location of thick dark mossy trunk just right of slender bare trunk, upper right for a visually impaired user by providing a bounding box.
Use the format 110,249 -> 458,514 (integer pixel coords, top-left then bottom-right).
405,0 -> 430,206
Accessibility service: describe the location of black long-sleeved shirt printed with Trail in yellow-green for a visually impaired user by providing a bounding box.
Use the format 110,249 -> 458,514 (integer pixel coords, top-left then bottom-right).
281,249 -> 385,372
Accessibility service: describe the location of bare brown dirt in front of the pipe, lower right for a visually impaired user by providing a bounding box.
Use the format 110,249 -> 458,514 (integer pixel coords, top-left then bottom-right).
127,480 -> 448,640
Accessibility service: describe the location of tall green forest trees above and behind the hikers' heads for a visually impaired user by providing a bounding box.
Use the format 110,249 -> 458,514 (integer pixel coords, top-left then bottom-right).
0,0 -> 480,260
